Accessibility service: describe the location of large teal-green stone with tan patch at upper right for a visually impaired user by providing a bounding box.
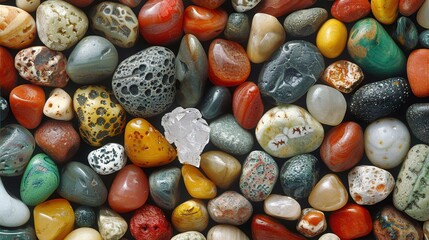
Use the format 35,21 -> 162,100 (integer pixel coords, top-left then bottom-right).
347,18 -> 406,77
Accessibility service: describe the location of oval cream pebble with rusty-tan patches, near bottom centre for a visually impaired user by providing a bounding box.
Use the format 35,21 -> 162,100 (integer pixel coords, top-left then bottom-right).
207,191 -> 253,225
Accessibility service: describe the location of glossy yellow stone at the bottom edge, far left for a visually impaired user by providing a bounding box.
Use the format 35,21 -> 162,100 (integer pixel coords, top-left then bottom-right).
33,198 -> 74,240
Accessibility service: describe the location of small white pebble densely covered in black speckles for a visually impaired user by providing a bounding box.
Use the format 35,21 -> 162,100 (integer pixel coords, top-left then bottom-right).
88,143 -> 127,175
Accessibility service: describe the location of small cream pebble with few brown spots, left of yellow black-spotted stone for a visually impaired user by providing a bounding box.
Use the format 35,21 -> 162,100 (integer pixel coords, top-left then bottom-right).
43,88 -> 74,121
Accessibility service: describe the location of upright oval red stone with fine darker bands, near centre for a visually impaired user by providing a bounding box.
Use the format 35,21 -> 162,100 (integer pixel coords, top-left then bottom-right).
232,82 -> 264,129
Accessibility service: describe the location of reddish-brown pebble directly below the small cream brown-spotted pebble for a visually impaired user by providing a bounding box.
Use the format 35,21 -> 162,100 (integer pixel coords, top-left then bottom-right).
34,120 -> 80,164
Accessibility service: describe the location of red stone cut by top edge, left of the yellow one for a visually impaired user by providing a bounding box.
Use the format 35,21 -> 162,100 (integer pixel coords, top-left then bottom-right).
331,0 -> 371,23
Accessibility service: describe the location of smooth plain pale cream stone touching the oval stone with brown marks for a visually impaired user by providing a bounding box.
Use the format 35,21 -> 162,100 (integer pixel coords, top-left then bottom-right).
307,84 -> 347,126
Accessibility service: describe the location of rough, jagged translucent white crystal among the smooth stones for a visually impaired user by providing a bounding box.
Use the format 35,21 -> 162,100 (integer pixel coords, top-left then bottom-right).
161,107 -> 210,167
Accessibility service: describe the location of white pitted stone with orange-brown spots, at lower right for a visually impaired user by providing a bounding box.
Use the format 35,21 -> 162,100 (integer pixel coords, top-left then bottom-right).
348,165 -> 395,205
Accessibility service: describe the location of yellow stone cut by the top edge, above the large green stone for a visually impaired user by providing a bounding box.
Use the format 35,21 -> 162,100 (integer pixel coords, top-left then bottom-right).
371,0 -> 399,25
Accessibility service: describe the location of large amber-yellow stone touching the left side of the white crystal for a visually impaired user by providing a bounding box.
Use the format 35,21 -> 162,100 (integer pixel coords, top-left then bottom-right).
124,118 -> 177,167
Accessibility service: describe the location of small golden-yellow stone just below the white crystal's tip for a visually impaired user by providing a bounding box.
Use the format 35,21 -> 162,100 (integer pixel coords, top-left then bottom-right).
182,164 -> 217,199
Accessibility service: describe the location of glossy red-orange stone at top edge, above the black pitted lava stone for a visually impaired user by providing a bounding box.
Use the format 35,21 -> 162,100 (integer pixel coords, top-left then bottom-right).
138,0 -> 184,45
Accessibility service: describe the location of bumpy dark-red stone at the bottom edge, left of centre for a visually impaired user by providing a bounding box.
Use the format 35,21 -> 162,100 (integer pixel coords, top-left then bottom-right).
130,204 -> 173,240
